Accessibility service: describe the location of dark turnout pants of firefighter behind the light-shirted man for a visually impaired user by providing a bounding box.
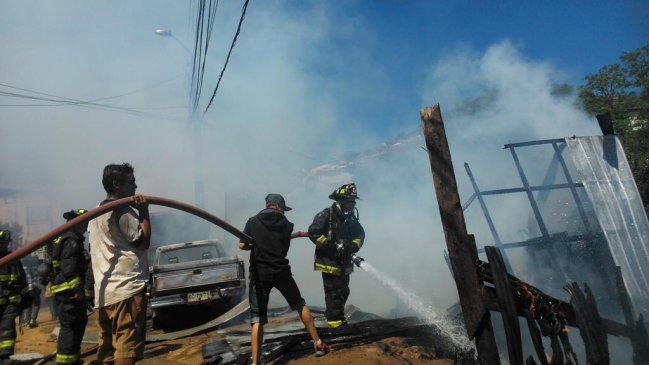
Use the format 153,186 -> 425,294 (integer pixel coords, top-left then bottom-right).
54,290 -> 88,365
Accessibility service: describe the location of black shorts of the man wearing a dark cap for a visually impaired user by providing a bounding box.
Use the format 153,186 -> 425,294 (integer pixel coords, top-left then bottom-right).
248,270 -> 306,325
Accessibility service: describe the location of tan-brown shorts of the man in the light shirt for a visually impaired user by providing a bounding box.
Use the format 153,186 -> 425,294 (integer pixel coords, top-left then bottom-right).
97,293 -> 147,363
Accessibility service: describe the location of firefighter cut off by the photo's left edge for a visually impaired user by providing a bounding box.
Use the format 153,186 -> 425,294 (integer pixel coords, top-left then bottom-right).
0,229 -> 33,360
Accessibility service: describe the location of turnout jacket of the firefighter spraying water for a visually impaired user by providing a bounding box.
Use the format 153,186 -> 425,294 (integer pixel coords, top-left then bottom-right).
309,203 -> 365,275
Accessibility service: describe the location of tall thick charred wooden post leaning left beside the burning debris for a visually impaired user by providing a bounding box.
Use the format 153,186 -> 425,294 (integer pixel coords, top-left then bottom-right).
419,104 -> 500,365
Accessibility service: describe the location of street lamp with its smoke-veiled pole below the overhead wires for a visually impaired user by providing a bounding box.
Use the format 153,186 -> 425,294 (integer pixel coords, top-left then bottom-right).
155,29 -> 205,208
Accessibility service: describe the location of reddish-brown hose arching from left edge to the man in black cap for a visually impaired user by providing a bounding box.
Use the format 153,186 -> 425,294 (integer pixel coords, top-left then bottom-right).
0,196 -> 252,268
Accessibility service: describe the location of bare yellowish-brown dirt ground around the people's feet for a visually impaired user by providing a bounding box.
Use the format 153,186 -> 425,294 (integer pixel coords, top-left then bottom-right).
15,306 -> 453,365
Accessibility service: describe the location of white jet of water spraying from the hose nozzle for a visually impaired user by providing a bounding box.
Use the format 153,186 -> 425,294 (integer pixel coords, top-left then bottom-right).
360,261 -> 475,351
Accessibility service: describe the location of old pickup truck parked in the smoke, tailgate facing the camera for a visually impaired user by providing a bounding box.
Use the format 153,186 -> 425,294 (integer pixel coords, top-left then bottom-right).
148,239 -> 246,327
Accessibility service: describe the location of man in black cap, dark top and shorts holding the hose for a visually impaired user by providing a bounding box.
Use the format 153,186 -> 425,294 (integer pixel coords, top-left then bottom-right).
239,194 -> 329,365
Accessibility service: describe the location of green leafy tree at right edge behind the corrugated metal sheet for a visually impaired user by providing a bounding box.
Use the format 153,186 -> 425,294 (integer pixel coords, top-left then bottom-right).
579,44 -> 649,214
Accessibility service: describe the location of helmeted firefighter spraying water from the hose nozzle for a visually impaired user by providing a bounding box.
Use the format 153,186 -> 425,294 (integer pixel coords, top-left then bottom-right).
309,183 -> 365,328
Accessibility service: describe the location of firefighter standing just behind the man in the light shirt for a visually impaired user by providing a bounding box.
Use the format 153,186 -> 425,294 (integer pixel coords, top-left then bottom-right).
51,209 -> 94,365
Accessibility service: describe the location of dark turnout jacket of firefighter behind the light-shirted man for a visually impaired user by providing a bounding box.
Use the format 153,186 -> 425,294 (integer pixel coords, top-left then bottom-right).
50,230 -> 94,297
